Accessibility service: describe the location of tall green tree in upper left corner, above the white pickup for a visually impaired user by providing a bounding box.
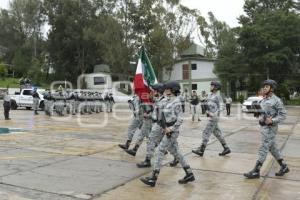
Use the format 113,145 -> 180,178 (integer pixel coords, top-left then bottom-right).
0,0 -> 44,76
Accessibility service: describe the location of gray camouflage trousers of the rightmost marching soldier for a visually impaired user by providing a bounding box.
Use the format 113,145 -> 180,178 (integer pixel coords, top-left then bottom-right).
258,126 -> 282,163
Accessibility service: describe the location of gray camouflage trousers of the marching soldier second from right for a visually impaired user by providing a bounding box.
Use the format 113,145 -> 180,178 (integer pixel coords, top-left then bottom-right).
202,118 -> 226,146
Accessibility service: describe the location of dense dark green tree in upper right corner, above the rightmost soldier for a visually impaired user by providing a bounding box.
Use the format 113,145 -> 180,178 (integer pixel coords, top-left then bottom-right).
238,0 -> 300,83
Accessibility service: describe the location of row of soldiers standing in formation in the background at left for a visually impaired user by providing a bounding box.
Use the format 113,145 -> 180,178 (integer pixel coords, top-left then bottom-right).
44,91 -> 115,116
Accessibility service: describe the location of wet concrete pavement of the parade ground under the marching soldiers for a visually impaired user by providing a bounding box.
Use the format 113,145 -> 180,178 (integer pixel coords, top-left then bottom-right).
0,106 -> 300,200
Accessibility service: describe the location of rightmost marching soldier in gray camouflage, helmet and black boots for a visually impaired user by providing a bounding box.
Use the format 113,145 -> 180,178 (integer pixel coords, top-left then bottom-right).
244,79 -> 289,178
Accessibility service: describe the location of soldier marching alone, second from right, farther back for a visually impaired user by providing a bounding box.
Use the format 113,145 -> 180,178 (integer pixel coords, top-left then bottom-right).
192,81 -> 231,157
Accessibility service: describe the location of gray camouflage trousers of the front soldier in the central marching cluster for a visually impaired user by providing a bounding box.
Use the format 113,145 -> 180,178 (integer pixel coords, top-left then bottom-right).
154,131 -> 189,171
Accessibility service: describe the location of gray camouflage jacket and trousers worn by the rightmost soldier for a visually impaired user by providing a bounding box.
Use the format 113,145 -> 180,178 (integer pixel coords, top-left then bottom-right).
258,94 -> 286,163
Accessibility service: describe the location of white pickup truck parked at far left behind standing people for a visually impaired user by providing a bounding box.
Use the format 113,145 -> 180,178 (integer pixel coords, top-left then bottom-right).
10,89 -> 44,110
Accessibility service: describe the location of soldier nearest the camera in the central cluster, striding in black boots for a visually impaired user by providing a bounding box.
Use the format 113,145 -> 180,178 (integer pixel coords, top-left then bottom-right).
140,81 -> 195,187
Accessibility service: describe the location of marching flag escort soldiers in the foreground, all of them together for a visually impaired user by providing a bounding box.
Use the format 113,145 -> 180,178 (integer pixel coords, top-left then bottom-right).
119,80 -> 289,187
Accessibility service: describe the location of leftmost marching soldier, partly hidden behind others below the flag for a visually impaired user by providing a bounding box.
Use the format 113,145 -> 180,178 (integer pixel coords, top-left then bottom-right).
119,95 -> 143,150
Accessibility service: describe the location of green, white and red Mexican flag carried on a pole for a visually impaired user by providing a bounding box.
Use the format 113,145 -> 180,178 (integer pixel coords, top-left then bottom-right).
134,47 -> 157,103
